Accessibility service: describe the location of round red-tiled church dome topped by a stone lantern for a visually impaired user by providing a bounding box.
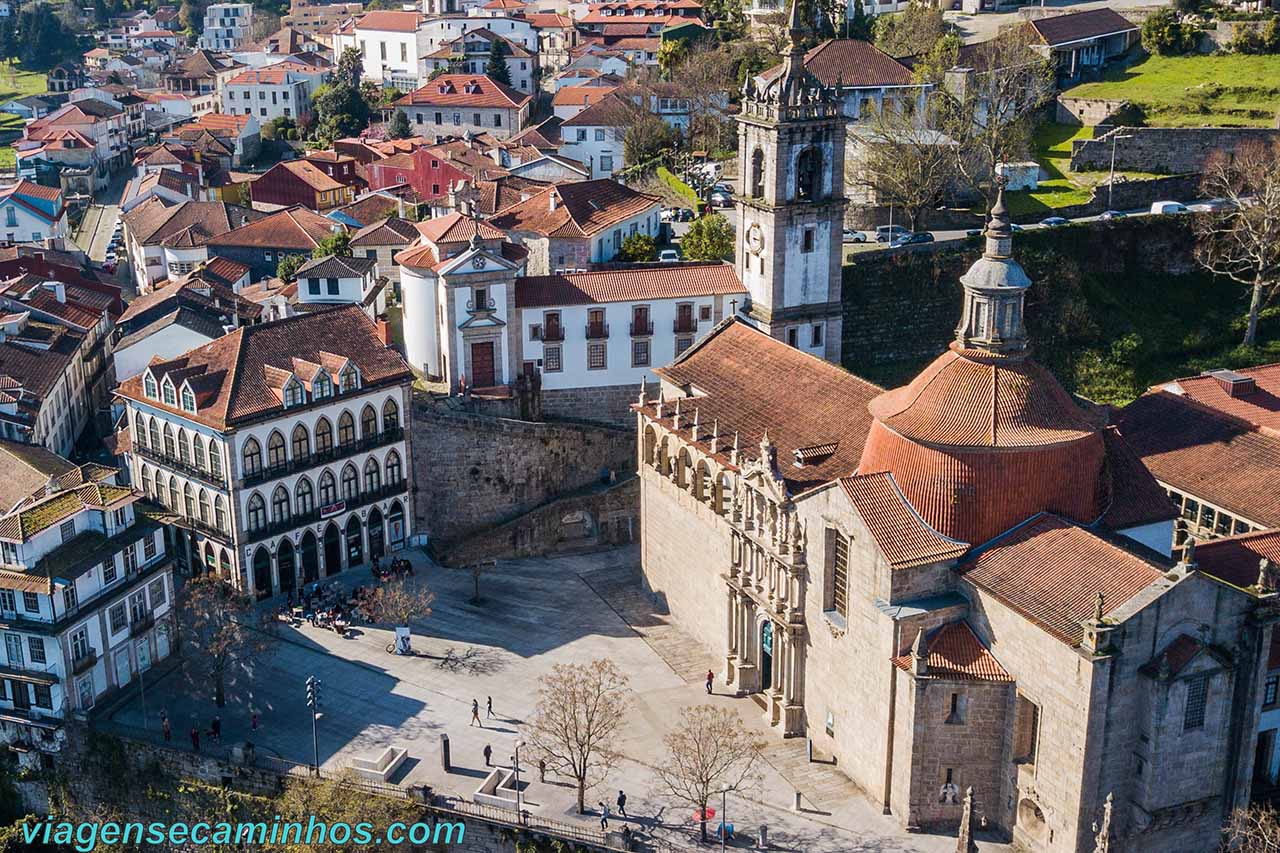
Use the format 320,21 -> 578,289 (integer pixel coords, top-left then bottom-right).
858,189 -> 1106,544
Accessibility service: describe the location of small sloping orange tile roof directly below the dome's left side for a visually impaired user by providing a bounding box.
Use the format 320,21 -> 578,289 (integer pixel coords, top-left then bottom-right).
840,474 -> 969,569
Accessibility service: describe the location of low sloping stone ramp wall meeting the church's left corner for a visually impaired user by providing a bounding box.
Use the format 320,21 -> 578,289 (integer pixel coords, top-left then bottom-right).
438,475 -> 640,566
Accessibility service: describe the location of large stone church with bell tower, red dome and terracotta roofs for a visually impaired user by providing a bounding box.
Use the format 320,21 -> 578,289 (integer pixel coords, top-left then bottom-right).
634,13 -> 1276,853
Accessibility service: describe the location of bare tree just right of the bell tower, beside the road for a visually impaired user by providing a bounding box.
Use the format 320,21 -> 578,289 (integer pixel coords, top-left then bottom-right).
845,97 -> 957,231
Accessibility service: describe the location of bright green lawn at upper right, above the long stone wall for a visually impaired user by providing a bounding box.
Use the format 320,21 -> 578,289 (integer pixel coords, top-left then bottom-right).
1064,54 -> 1280,127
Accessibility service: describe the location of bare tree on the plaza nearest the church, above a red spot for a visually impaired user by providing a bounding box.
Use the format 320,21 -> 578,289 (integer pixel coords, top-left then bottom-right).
655,704 -> 764,841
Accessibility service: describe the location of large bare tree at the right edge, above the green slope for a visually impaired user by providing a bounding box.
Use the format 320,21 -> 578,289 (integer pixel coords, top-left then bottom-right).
1196,142 -> 1280,347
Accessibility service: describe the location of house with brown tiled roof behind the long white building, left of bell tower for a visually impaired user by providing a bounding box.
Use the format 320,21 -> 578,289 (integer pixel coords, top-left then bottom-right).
489,179 -> 662,275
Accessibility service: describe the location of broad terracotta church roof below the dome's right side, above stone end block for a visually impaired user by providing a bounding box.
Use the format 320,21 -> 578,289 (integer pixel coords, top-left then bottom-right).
960,512 -> 1162,646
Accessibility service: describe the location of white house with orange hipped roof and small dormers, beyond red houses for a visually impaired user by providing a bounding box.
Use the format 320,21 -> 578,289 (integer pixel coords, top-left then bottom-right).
396,74 -> 534,138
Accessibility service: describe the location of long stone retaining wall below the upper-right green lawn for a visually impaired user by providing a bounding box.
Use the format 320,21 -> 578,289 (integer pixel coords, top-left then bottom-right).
1071,127 -> 1280,174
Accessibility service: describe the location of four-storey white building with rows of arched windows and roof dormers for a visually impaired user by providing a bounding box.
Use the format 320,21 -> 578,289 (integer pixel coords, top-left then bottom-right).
118,305 -> 412,598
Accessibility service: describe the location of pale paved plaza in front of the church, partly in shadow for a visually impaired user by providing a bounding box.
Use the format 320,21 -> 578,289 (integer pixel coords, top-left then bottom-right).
110,547 -> 1009,853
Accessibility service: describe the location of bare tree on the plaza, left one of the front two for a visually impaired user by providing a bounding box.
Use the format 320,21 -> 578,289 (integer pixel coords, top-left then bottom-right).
525,658 -> 627,815
